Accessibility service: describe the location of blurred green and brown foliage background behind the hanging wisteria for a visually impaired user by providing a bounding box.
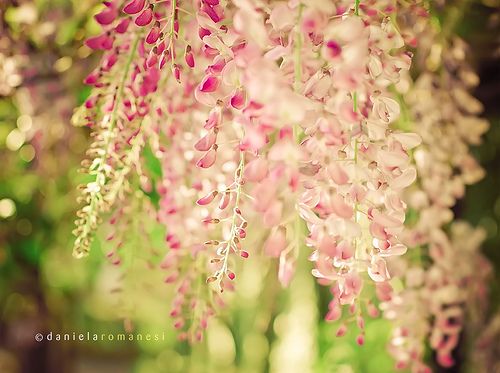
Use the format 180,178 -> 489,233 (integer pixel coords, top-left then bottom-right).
0,0 -> 500,373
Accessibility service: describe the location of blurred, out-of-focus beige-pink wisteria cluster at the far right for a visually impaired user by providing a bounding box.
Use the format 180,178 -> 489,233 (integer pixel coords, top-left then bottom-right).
382,7 -> 491,372
